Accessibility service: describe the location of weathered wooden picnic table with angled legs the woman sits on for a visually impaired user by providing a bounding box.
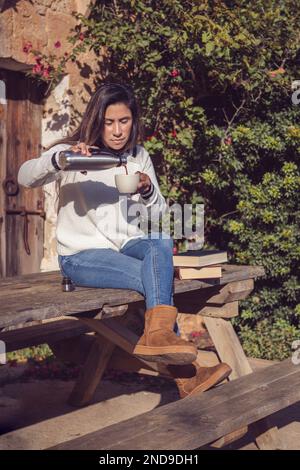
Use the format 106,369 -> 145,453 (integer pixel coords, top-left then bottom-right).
0,264 -> 290,449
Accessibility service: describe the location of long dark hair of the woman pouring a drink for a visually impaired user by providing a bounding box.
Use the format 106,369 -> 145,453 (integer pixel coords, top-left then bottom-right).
48,83 -> 141,150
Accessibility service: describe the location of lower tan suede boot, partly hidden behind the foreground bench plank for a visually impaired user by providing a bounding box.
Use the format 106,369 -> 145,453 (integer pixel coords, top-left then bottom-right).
167,362 -> 232,398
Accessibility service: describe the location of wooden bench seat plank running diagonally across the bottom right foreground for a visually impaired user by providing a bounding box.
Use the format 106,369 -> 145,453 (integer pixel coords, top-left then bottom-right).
48,359 -> 300,450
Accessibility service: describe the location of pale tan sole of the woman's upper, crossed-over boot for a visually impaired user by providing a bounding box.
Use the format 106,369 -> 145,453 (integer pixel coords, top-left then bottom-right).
132,346 -> 197,365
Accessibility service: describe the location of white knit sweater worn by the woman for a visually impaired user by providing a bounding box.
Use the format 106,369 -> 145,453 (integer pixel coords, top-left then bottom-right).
18,144 -> 167,255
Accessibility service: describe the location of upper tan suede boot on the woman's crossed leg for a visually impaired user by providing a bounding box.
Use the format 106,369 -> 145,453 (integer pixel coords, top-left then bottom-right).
133,305 -> 197,364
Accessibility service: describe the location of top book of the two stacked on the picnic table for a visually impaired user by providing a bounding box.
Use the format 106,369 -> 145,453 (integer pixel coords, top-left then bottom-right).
173,250 -> 228,268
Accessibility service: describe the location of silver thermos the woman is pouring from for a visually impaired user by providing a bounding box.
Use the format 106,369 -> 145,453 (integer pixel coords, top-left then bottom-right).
57,149 -> 127,171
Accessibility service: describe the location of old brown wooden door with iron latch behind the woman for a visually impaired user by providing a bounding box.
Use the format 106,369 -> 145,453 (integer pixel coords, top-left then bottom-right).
0,69 -> 44,276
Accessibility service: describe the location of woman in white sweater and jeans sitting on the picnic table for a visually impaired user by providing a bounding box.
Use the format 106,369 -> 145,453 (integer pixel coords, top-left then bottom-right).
18,83 -> 228,392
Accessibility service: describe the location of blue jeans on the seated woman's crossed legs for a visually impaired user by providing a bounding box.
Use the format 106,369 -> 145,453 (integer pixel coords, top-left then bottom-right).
58,233 -> 174,309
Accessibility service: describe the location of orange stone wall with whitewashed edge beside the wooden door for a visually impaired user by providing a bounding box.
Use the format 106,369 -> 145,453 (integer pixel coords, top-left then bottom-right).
0,0 -> 96,271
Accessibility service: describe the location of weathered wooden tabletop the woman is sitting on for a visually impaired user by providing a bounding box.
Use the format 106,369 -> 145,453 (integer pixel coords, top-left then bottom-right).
0,265 -> 262,328
